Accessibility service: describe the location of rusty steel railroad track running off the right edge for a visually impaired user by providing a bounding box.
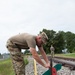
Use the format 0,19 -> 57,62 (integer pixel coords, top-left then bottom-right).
41,56 -> 75,70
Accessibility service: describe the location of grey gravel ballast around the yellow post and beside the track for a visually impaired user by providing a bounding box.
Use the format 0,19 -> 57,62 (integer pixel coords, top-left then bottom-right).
25,57 -> 75,75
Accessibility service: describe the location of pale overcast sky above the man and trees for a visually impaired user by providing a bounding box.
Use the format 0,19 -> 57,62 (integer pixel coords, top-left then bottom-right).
0,0 -> 75,53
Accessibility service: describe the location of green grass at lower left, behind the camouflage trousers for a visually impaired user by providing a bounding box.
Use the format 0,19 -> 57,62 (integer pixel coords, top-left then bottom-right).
0,59 -> 28,75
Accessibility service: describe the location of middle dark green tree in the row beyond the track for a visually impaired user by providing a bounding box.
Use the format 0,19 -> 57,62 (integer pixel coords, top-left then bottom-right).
54,31 -> 65,53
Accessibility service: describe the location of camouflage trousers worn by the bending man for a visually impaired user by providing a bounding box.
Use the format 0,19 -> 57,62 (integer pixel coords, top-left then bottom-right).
6,40 -> 25,75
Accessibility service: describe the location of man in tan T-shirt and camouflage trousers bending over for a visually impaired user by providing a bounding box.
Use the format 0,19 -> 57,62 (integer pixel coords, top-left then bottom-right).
6,32 -> 50,75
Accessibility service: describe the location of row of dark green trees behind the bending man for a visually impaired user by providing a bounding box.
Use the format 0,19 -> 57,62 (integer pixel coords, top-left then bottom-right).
40,29 -> 75,54
